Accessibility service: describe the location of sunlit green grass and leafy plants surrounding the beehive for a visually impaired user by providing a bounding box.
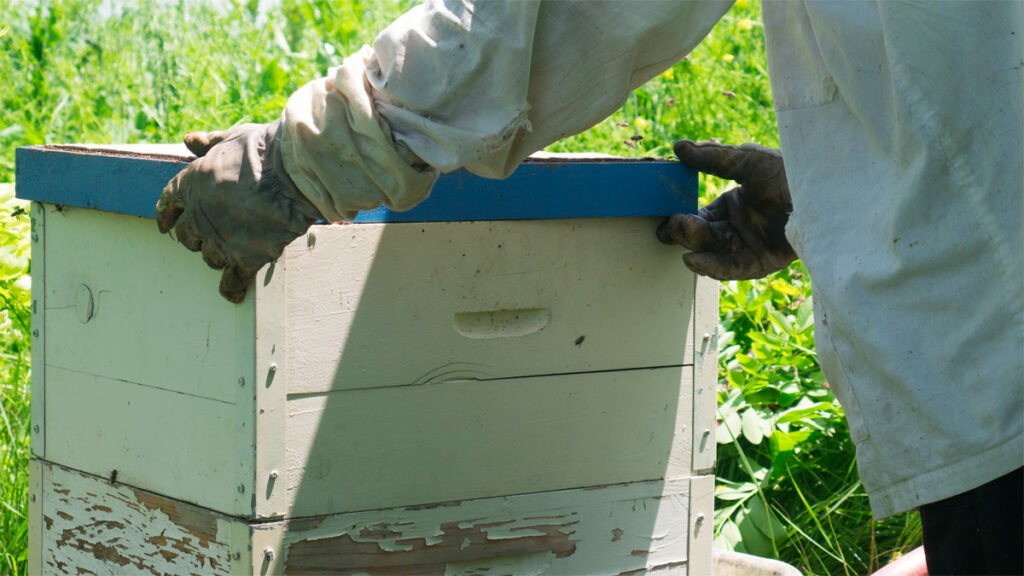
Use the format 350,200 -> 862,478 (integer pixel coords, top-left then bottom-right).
0,0 -> 921,575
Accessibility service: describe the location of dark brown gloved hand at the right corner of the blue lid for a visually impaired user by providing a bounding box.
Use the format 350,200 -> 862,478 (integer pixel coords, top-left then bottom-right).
657,140 -> 797,280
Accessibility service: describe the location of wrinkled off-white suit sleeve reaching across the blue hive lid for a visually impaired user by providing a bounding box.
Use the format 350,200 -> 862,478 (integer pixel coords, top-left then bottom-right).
283,0 -> 732,219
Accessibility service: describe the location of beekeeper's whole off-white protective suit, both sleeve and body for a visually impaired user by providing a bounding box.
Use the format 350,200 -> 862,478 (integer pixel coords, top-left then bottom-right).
283,0 -> 1024,518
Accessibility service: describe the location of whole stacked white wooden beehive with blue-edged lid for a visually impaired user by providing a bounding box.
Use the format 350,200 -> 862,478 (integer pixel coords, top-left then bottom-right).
17,148 -> 717,575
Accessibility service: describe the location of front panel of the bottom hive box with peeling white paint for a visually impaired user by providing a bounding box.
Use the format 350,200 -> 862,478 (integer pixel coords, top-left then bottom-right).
285,479 -> 696,576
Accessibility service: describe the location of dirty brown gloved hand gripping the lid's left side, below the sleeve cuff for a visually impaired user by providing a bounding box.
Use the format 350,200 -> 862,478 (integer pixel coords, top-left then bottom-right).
157,120 -> 322,302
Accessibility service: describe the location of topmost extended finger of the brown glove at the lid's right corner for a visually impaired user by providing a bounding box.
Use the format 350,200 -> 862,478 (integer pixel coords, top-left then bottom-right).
673,140 -> 782,183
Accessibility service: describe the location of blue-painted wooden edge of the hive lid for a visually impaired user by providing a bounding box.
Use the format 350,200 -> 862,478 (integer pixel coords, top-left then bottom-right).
15,147 -> 697,222
